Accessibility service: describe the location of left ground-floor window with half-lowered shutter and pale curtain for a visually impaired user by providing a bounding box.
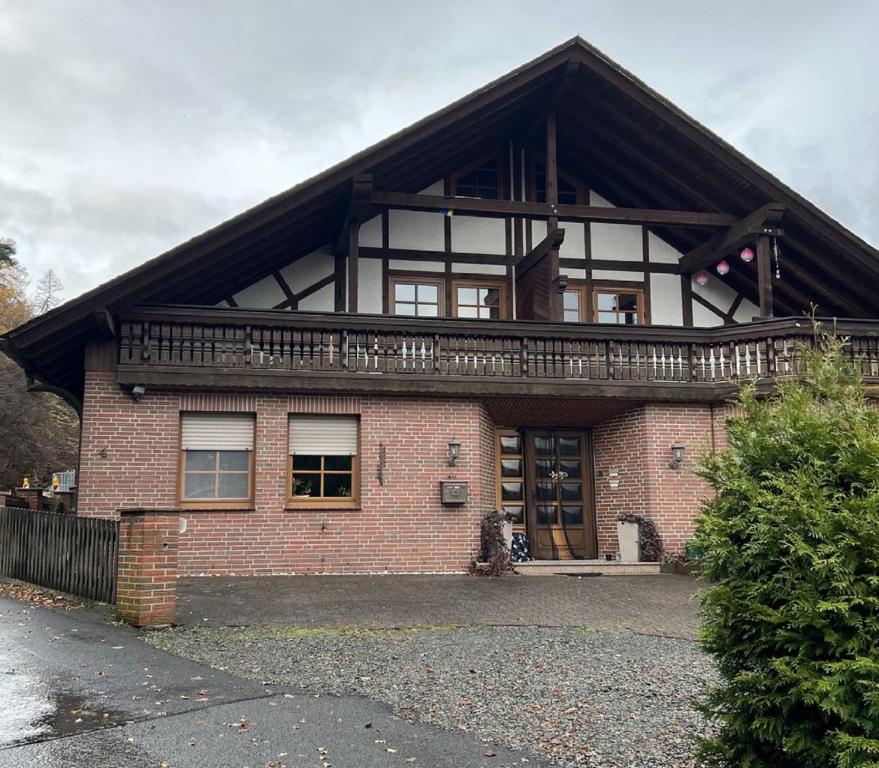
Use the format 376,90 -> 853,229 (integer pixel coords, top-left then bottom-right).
180,413 -> 255,506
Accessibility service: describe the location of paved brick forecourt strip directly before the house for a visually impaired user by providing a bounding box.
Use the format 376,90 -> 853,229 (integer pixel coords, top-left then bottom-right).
176,574 -> 698,639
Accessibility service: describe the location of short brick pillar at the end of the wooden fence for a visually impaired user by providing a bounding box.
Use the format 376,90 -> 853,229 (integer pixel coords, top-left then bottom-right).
116,509 -> 180,629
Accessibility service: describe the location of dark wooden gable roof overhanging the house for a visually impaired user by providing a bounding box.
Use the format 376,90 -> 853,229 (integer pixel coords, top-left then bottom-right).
7,37 -> 879,392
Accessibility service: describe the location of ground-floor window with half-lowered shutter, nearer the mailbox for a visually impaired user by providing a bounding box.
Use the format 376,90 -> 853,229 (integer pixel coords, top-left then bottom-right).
287,414 -> 359,506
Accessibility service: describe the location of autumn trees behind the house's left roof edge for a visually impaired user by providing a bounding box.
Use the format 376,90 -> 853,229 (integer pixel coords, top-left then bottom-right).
0,243 -> 79,490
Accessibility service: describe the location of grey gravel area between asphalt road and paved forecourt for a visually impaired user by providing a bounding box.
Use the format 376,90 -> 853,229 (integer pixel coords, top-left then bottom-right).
149,626 -> 714,768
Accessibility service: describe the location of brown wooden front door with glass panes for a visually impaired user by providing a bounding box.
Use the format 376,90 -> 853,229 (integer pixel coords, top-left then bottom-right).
525,430 -> 598,560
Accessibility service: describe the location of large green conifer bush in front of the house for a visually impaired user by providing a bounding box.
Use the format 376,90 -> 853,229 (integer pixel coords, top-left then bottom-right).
694,337 -> 879,768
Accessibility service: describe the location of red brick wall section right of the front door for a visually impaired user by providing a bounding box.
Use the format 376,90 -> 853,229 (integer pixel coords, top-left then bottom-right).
593,403 -> 726,557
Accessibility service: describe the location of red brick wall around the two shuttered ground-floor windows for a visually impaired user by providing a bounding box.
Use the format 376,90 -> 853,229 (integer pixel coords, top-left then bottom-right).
79,371 -> 494,574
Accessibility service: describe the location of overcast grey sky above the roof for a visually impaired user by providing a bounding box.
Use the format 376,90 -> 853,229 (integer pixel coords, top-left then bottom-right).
0,0 -> 879,298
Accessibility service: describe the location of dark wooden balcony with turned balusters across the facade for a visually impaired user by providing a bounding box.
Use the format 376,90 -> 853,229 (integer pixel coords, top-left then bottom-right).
117,307 -> 879,401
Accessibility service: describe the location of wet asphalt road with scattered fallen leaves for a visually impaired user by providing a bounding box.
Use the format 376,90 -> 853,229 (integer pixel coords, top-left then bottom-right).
0,598 -> 535,768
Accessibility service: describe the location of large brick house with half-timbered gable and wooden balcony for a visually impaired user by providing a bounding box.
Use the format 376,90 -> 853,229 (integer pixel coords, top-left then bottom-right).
3,38 -> 879,574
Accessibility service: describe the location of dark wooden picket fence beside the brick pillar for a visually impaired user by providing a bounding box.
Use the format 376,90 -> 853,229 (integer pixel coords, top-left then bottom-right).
0,507 -> 119,603
